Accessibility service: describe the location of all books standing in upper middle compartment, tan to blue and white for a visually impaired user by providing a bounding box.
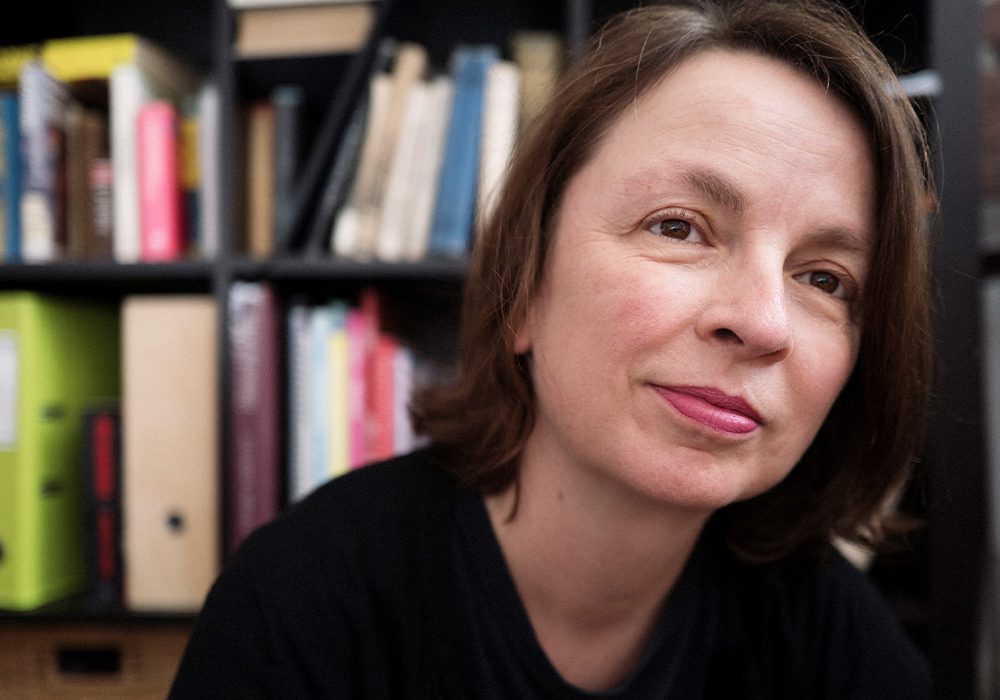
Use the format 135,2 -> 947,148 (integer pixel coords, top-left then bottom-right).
245,29 -> 563,263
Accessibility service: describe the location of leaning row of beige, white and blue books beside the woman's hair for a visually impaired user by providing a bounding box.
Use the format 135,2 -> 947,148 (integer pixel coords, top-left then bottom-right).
307,32 -> 561,262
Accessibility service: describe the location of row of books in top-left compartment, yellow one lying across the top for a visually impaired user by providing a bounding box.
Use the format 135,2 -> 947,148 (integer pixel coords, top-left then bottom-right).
0,33 -> 219,263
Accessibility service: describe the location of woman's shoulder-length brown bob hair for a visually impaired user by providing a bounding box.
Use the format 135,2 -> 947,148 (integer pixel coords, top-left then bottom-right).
413,0 -> 931,561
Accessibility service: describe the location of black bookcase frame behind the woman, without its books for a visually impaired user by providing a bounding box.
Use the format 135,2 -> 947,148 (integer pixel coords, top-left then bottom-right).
0,0 -> 988,697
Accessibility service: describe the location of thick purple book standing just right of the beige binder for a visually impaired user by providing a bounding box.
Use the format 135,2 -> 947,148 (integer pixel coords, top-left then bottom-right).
226,281 -> 280,554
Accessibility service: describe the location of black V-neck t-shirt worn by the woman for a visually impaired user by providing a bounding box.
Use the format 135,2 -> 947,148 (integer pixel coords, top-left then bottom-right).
171,452 -> 930,700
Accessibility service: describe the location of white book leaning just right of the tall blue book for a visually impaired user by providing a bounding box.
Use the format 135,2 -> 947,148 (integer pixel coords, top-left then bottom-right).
476,61 -> 521,227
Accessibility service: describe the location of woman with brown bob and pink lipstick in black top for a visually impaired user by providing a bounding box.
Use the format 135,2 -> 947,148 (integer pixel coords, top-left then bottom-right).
173,0 -> 930,698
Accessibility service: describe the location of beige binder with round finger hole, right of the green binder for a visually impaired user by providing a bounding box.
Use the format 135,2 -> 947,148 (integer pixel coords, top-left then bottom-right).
121,295 -> 222,613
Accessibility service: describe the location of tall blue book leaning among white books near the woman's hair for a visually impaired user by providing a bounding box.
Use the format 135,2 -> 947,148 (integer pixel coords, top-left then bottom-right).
427,45 -> 500,258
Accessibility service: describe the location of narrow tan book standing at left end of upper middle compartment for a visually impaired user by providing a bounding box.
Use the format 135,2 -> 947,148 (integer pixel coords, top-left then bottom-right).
246,99 -> 275,259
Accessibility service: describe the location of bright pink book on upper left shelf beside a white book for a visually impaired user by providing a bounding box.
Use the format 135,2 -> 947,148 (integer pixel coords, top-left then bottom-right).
137,100 -> 185,262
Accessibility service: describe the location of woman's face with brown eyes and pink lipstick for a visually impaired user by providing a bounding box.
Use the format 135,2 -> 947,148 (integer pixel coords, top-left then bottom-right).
515,50 -> 875,510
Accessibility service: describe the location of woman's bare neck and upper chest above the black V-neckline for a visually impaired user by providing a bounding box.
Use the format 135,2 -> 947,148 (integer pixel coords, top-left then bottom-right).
485,440 -> 710,690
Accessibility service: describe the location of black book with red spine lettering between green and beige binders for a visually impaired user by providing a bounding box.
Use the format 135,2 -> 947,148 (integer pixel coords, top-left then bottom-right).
83,404 -> 123,610
